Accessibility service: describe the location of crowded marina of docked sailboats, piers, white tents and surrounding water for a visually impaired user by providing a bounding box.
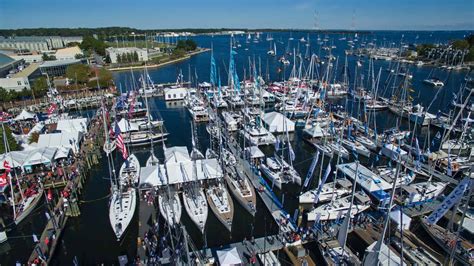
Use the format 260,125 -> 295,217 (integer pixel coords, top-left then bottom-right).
0,17 -> 474,265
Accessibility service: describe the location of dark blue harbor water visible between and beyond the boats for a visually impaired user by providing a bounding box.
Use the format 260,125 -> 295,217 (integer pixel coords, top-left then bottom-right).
0,31 -> 468,265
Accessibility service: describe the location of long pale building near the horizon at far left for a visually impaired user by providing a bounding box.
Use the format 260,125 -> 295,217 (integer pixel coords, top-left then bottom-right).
0,36 -> 82,52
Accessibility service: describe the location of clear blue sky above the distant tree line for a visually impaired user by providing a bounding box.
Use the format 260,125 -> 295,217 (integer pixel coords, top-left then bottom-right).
0,0 -> 474,30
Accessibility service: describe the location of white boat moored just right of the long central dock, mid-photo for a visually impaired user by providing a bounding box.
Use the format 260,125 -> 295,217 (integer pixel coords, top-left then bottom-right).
260,156 -> 301,189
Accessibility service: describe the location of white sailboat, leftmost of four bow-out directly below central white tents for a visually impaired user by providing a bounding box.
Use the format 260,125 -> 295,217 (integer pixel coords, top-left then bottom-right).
158,191 -> 182,227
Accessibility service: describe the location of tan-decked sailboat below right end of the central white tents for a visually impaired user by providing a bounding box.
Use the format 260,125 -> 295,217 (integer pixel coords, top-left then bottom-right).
206,182 -> 234,232
